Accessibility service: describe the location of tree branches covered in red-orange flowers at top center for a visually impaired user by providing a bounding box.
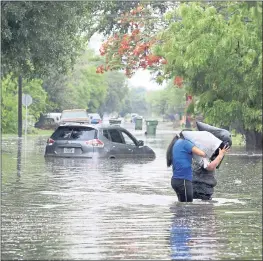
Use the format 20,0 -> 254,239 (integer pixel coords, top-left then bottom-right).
97,5 -> 177,83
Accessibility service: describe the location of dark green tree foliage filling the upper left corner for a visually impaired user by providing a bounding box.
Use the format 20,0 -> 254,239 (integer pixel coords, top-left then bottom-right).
1,1 -> 96,78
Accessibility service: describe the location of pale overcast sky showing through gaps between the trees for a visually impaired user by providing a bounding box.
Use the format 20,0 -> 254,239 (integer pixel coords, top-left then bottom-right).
89,34 -> 166,90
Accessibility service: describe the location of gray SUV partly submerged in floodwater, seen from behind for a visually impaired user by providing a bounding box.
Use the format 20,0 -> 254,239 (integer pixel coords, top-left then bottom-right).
45,123 -> 155,159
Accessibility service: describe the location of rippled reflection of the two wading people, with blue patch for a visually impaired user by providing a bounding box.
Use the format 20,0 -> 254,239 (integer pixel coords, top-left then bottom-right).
170,202 -> 220,260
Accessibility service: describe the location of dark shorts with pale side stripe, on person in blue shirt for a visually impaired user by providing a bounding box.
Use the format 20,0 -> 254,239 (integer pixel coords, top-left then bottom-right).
171,178 -> 193,202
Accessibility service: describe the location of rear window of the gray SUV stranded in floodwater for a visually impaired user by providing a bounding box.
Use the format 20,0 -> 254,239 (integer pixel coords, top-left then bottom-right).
51,126 -> 97,140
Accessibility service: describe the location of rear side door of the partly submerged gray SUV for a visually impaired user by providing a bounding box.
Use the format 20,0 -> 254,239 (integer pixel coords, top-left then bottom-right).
108,129 -> 133,158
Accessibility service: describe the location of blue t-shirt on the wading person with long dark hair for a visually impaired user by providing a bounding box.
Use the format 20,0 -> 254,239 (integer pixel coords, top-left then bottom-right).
173,139 -> 194,181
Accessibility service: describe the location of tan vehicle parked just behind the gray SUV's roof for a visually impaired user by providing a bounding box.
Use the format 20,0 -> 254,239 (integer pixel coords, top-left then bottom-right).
60,109 -> 90,124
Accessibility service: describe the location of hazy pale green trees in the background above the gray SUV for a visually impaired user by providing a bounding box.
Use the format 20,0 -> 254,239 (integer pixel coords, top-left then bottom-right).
44,50 -> 128,113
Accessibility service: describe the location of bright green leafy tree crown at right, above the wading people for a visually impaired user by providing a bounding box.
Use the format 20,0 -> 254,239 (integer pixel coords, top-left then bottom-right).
154,3 -> 262,130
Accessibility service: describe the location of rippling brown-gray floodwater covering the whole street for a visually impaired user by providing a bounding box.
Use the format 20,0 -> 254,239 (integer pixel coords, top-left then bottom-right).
1,124 -> 262,260
